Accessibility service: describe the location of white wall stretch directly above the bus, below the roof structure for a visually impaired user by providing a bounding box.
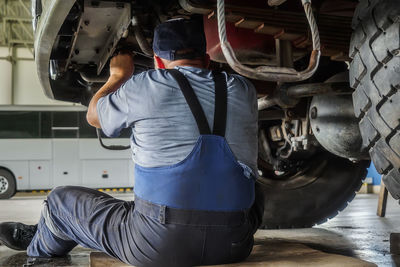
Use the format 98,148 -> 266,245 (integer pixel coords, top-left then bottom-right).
0,47 -> 77,106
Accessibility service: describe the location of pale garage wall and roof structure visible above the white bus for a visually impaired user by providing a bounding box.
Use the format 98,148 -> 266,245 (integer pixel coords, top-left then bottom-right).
0,0 -> 74,106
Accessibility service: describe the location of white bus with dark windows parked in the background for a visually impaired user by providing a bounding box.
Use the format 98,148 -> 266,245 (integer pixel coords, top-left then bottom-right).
0,106 -> 134,199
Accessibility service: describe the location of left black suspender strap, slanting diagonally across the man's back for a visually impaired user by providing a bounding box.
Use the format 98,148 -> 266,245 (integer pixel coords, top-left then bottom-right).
168,69 -> 211,134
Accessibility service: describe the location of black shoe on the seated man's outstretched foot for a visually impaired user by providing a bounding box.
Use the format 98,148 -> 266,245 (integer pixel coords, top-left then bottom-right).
0,222 -> 37,250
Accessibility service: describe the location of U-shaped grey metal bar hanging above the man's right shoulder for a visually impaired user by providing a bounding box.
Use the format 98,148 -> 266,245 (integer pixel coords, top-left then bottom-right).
217,0 -> 321,82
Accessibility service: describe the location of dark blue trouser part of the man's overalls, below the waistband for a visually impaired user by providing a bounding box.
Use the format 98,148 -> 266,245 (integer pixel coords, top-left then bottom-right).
27,186 -> 258,266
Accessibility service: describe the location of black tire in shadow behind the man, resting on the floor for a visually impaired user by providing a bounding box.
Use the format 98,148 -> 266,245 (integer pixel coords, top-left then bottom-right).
256,152 -> 369,229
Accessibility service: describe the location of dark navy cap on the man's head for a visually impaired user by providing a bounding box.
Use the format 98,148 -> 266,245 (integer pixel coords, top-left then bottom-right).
153,18 -> 207,61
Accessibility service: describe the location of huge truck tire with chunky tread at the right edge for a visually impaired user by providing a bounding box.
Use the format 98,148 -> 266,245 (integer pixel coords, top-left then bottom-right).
349,0 -> 400,199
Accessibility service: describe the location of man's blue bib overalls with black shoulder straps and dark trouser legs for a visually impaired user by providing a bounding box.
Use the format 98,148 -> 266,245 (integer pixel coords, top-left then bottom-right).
27,70 -> 258,267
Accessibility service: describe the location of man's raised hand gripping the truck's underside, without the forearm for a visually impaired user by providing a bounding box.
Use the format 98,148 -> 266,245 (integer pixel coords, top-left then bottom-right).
110,53 -> 135,82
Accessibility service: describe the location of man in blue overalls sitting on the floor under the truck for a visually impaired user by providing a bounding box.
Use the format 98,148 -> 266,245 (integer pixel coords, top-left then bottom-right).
0,19 -> 259,266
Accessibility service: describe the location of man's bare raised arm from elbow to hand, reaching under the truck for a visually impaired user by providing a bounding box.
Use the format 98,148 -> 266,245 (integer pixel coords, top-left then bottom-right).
86,54 -> 134,128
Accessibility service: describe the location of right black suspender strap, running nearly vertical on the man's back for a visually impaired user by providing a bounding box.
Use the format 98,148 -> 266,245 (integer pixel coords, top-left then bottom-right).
213,71 -> 228,137
